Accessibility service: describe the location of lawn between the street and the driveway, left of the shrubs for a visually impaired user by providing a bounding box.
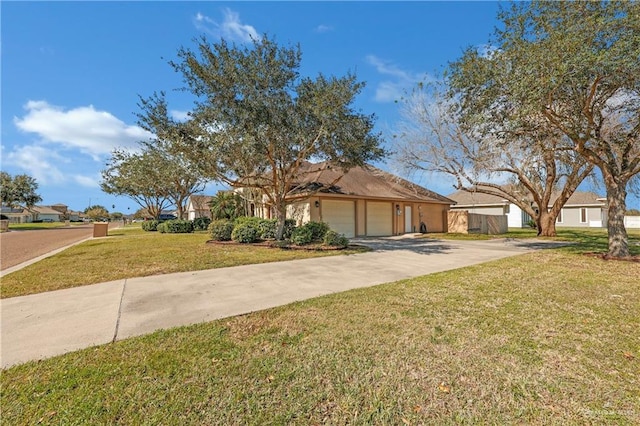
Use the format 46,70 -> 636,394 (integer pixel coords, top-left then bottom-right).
0,226 -> 365,298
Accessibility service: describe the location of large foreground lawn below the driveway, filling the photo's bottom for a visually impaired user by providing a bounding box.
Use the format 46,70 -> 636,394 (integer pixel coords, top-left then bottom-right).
0,249 -> 640,425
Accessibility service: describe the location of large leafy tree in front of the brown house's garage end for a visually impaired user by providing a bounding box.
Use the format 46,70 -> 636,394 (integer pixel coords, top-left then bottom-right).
171,36 -> 385,238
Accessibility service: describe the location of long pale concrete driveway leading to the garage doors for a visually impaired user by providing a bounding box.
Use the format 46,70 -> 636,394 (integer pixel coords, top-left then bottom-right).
0,237 -> 557,368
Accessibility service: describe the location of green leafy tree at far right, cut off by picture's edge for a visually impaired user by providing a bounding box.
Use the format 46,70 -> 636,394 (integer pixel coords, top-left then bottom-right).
449,1 -> 640,257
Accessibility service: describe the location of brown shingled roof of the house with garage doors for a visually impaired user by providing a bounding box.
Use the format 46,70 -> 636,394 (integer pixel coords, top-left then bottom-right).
295,162 -> 454,204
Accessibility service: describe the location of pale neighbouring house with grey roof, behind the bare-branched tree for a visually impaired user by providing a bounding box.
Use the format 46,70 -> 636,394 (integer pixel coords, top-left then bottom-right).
448,190 -> 607,228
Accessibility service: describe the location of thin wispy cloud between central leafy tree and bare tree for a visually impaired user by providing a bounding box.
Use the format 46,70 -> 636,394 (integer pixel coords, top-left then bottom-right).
366,55 -> 433,103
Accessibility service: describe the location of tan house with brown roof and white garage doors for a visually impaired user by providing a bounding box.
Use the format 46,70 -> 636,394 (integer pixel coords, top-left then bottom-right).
254,162 -> 454,238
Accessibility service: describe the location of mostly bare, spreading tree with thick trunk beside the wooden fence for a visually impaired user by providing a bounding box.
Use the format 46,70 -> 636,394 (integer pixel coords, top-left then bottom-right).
395,84 -> 593,236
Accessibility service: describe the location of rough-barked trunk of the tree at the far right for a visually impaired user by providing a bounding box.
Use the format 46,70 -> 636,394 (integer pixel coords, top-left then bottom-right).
606,182 -> 629,257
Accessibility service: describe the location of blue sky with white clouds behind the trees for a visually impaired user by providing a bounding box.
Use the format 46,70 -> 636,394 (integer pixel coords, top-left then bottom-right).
1,1 -> 640,213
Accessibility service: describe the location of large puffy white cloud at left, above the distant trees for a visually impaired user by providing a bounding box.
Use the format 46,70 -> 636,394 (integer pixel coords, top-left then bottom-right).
13,101 -> 151,161
